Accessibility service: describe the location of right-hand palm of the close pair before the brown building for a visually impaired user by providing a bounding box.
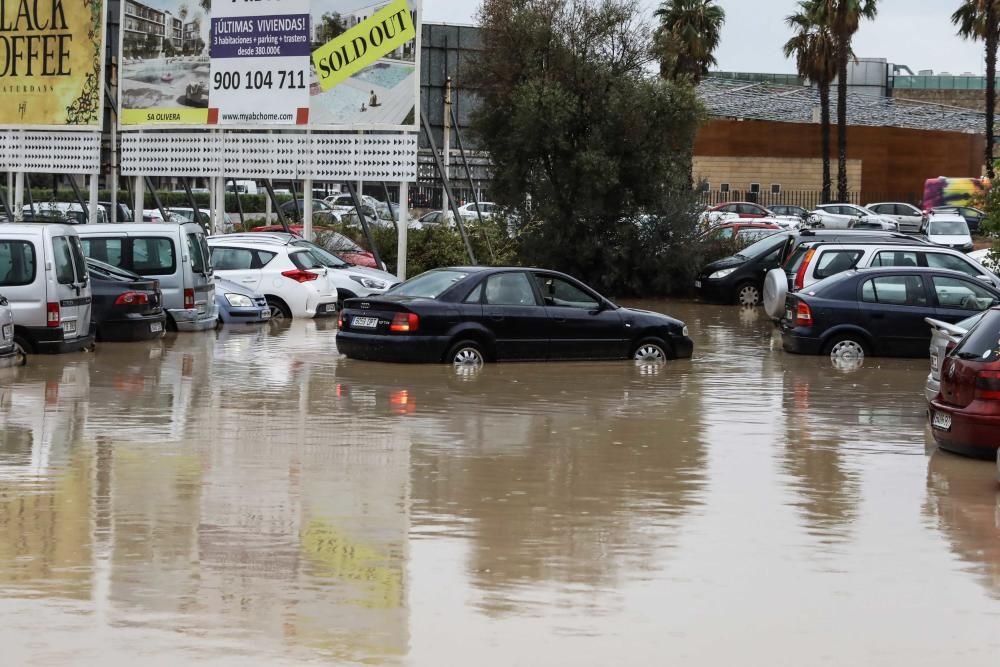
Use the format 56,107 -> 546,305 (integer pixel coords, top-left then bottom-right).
816,0 -> 878,201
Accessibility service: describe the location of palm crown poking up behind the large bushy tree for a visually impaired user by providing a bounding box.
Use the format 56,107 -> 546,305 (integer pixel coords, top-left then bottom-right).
654,0 -> 726,83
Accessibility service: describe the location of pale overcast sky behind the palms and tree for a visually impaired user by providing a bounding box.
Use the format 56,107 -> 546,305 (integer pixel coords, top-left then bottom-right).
424,0 -> 985,74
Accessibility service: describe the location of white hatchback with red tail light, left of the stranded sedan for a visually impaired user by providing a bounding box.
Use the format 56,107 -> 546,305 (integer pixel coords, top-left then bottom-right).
208,236 -> 337,320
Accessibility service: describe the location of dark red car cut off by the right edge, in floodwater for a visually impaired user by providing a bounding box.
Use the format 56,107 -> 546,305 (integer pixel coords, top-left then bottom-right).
930,308 -> 1000,459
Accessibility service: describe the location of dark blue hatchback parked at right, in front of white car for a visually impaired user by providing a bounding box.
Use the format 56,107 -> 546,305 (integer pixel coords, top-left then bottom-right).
781,267 -> 1000,361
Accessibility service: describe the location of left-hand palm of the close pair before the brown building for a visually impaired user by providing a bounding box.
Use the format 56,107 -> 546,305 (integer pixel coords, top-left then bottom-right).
784,0 -> 837,204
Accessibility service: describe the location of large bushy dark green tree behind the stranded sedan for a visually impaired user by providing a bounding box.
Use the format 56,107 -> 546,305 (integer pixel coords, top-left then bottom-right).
467,0 -> 702,293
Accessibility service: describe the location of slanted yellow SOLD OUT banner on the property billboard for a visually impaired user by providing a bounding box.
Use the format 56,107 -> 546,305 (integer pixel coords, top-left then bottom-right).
313,0 -> 417,91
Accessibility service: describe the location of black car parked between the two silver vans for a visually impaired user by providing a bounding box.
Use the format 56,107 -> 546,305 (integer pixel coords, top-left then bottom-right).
87,259 -> 166,341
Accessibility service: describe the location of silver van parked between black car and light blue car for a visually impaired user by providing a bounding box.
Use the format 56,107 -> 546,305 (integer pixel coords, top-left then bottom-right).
77,222 -> 219,331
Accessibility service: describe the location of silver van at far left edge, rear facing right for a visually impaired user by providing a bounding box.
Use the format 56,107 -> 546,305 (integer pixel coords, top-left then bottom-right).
0,223 -> 94,354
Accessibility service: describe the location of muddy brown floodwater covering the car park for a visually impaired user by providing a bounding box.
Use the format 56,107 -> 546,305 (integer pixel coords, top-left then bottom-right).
0,302 -> 1000,667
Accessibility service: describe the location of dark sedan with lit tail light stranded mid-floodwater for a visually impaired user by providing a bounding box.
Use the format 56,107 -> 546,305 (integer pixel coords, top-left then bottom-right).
337,267 -> 694,365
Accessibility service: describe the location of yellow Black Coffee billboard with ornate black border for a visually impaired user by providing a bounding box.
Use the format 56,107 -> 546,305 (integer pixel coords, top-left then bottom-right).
0,0 -> 105,130
